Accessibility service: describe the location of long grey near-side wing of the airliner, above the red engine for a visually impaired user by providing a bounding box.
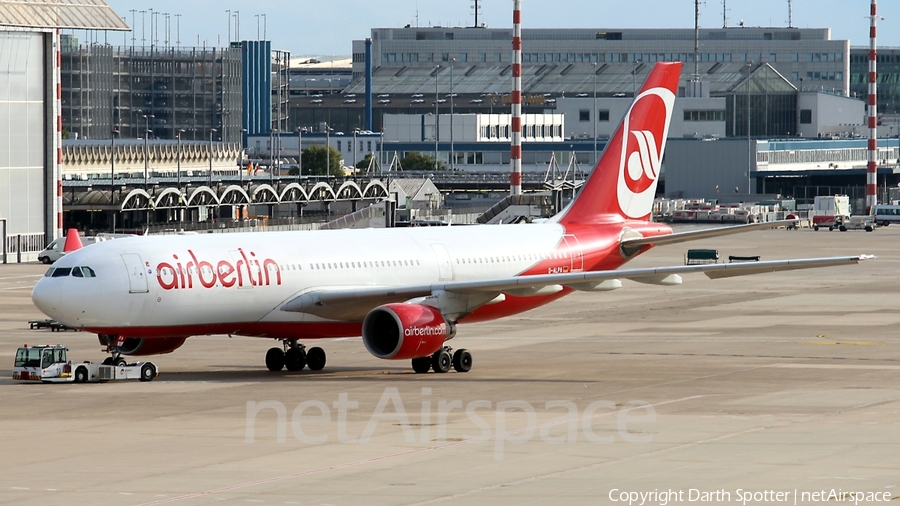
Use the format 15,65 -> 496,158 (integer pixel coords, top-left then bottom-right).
281,255 -> 874,321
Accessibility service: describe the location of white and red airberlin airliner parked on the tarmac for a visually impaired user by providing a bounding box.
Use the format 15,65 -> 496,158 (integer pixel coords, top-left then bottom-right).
32,63 -> 865,372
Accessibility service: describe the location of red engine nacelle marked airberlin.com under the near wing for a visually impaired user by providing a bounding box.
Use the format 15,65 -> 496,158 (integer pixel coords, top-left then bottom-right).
362,304 -> 452,360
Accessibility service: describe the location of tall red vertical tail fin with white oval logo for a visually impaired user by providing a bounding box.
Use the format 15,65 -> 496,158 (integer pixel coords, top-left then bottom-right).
559,62 -> 681,224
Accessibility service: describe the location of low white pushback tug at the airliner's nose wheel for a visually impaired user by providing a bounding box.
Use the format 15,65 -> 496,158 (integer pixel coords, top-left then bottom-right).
13,344 -> 159,383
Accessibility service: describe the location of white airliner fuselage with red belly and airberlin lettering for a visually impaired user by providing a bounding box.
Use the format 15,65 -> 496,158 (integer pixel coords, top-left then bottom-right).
35,222 -> 670,339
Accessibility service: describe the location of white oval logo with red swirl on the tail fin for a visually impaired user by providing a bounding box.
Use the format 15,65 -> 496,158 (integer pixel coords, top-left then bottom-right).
616,87 -> 675,219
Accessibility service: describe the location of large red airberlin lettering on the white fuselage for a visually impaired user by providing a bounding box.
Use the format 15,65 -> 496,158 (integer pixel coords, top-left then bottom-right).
156,248 -> 281,290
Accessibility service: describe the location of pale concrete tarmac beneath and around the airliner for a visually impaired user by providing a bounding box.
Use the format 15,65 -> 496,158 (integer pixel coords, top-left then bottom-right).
0,226 -> 900,505
